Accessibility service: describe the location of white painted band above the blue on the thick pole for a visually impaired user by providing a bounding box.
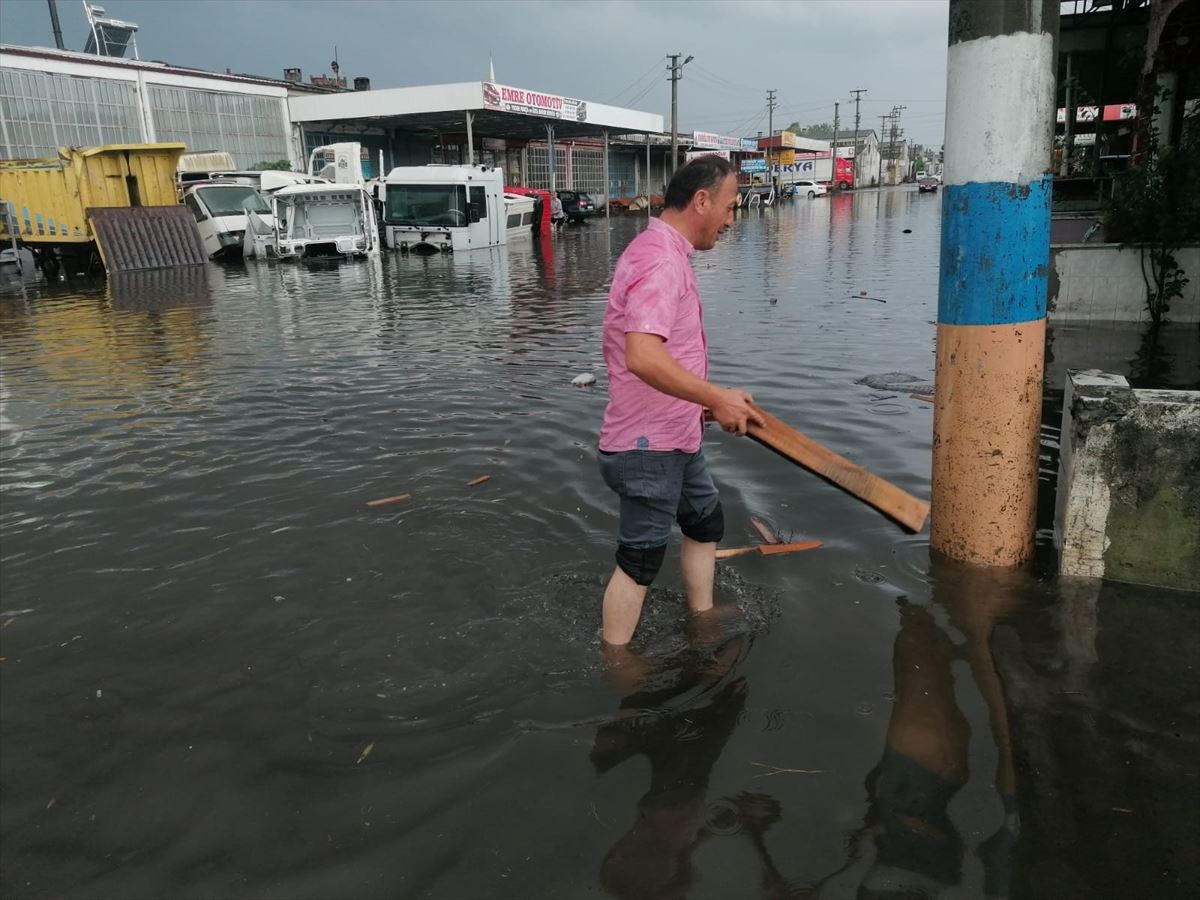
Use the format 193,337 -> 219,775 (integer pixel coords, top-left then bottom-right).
944,31 -> 1056,185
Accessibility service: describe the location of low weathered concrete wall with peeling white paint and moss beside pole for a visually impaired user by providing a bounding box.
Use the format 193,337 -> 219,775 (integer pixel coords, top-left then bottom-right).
1055,370 -> 1200,590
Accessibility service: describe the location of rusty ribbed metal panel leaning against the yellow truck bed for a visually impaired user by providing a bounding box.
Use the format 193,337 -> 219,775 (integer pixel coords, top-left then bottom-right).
88,206 -> 208,274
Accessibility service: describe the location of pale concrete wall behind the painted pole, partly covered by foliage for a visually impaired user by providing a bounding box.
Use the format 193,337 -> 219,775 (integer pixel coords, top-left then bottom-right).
1050,244 -> 1200,324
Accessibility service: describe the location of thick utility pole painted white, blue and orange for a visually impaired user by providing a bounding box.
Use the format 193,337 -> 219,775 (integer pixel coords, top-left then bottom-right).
931,0 -> 1058,565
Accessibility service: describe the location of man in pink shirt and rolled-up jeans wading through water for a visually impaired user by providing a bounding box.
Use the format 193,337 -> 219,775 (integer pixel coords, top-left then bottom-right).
600,156 -> 764,647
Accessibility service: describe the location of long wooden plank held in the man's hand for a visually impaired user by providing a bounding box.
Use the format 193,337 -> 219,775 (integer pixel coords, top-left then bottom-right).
749,406 -> 929,532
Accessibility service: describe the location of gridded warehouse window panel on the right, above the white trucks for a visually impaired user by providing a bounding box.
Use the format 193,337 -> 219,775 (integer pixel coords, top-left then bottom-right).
150,85 -> 289,166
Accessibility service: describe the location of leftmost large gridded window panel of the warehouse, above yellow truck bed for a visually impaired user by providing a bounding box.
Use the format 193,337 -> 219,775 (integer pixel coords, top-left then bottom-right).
0,68 -> 144,160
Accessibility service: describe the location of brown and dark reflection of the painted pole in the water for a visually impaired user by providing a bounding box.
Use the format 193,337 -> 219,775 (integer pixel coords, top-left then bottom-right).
805,559 -> 1025,900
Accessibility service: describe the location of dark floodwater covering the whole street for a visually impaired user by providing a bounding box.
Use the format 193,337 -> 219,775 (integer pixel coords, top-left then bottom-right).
0,191 -> 1200,900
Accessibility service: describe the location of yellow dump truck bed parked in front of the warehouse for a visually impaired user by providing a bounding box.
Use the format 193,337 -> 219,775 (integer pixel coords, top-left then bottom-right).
0,144 -> 187,250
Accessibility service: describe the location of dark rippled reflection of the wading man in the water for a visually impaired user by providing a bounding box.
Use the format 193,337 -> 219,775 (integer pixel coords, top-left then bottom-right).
592,611 -> 786,900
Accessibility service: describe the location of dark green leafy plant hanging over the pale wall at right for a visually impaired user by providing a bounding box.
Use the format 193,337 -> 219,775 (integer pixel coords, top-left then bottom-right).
1104,118 -> 1200,326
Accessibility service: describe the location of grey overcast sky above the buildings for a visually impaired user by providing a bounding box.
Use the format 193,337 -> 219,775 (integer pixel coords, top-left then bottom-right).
0,0 -> 948,145
